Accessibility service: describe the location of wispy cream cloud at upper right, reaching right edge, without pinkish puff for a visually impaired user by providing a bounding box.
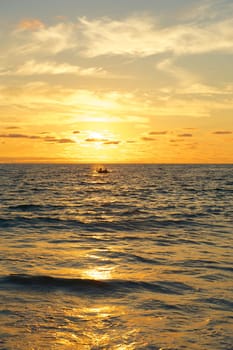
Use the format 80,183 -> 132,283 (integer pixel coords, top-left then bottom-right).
79,16 -> 233,57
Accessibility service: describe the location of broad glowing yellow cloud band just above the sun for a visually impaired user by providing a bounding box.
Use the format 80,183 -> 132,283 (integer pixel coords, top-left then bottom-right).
0,80 -> 229,125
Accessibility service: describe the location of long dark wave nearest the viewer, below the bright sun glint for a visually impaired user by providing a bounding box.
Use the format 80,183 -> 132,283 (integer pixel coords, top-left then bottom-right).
0,274 -> 193,295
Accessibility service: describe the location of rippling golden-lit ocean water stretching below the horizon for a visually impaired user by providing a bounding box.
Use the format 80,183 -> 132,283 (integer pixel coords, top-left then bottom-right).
0,164 -> 233,350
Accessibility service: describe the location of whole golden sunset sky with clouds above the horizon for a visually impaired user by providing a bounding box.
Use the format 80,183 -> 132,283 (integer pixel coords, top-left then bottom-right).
0,0 -> 233,164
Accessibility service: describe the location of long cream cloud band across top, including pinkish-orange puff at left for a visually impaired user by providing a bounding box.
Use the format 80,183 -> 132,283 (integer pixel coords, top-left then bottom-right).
9,4 -> 233,57
